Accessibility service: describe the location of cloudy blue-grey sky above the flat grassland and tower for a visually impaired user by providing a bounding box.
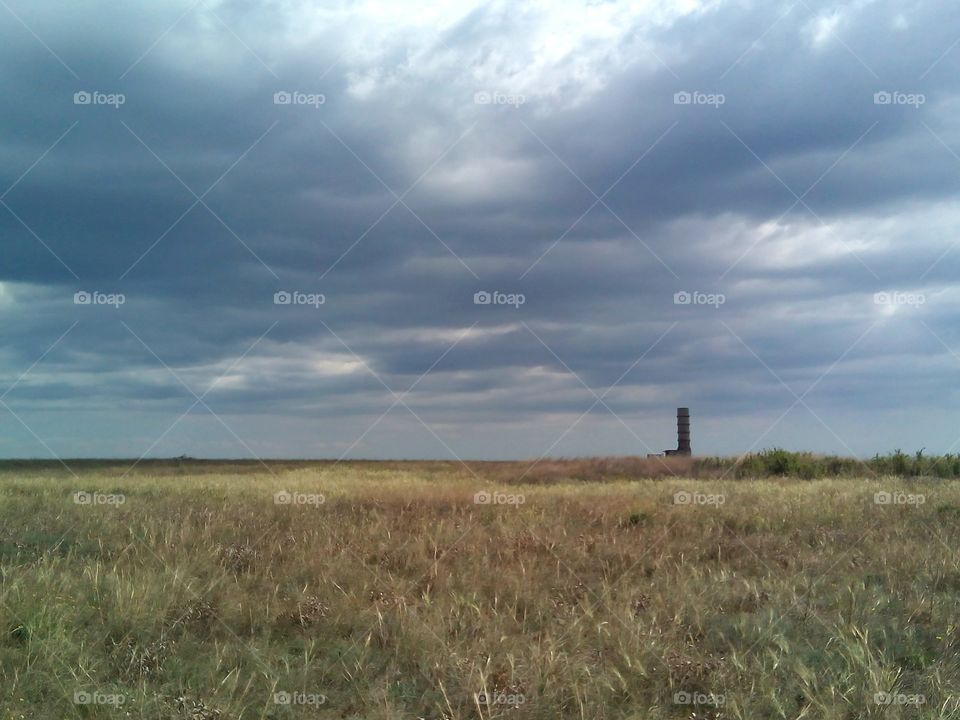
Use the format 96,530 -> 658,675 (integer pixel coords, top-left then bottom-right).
0,0 -> 960,459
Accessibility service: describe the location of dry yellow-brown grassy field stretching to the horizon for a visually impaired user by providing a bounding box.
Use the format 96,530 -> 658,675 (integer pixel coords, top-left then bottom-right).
0,457 -> 960,720
